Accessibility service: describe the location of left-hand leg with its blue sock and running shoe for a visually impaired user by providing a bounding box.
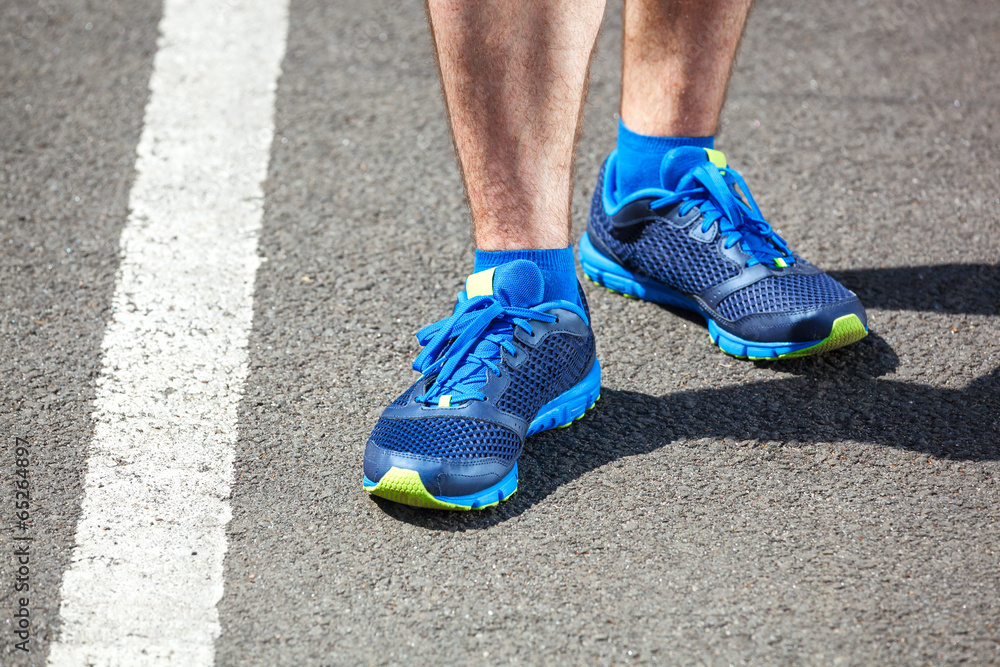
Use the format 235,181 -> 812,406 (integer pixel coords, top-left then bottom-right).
364,0 -> 603,509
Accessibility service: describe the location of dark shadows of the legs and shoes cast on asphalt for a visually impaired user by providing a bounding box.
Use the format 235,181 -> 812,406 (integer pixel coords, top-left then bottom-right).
374,264 -> 1000,530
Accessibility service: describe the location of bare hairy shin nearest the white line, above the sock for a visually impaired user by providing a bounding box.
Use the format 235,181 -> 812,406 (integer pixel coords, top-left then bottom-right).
427,0 -> 604,250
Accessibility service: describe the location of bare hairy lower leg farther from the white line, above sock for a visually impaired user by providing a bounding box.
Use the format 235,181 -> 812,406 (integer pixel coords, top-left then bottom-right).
621,0 -> 753,137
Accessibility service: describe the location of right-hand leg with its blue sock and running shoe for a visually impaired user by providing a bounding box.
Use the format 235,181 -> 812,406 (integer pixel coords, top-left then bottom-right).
580,0 -> 867,359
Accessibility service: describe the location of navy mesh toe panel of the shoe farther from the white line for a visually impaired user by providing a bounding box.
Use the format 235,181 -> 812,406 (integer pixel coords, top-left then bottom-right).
716,273 -> 851,322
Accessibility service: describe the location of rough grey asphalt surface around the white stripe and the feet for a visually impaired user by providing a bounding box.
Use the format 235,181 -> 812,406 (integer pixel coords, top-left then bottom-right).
0,0 -> 1000,665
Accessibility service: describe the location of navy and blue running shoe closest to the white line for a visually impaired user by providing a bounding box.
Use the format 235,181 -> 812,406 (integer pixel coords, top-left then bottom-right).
364,260 -> 601,510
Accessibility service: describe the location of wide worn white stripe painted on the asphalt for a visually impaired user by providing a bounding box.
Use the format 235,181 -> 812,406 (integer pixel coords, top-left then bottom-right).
49,0 -> 288,666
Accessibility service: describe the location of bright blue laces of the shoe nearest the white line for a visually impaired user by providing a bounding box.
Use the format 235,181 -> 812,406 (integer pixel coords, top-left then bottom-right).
413,293 -> 556,405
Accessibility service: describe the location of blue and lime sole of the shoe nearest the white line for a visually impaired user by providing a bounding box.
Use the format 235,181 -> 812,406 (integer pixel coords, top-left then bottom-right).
364,359 -> 601,511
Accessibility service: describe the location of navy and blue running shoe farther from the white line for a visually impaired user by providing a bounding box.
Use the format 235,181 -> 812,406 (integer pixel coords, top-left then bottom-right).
580,146 -> 868,359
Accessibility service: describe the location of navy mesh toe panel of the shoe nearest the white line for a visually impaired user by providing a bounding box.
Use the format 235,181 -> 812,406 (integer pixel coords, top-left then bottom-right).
369,417 -> 521,461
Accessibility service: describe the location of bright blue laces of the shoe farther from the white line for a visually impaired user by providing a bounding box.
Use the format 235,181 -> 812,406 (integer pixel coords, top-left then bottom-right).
650,162 -> 795,266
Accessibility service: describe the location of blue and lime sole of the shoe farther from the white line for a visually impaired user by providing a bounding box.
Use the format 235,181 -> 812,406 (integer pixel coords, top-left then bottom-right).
580,232 -> 868,360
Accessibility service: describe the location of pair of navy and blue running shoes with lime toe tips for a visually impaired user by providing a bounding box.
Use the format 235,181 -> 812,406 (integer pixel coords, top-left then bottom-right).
364,147 -> 868,510
